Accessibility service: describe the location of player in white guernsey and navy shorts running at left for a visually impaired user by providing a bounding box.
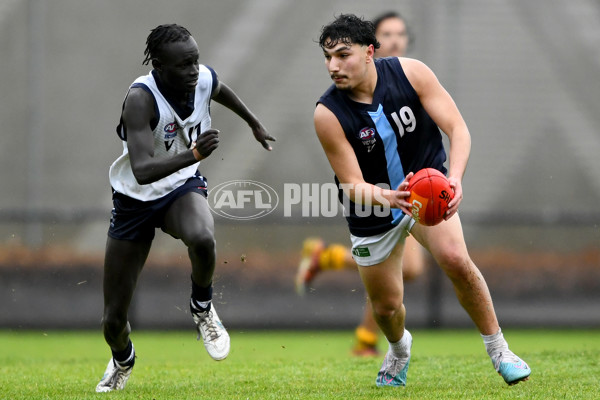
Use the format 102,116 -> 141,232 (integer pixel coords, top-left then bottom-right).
96,24 -> 274,392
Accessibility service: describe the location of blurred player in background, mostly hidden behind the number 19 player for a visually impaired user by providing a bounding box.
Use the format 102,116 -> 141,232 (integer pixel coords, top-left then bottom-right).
296,11 -> 426,356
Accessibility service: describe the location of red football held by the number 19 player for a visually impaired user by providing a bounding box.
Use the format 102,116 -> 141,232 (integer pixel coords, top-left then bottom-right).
406,168 -> 454,226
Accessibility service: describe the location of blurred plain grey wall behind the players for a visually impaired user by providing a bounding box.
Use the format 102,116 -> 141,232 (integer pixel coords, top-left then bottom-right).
0,0 -> 600,251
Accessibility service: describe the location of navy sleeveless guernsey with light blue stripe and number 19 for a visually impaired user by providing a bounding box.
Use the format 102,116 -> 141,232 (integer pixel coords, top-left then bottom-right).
317,57 -> 446,237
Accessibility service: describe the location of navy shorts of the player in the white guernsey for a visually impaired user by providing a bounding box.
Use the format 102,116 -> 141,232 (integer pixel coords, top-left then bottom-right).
108,175 -> 208,241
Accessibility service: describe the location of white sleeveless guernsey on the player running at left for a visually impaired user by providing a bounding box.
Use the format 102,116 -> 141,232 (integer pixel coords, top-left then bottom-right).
109,65 -> 216,201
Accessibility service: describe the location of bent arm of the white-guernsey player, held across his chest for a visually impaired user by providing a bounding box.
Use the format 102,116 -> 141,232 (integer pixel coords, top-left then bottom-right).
123,88 -> 214,185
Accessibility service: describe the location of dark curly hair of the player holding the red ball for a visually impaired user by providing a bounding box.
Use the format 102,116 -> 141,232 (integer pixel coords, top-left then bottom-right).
319,14 -> 379,49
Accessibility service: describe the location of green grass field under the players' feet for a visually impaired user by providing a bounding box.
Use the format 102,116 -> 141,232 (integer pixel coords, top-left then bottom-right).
0,329 -> 600,400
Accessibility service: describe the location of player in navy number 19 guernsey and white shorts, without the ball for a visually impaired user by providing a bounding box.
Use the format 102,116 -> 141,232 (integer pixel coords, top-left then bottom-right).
314,14 -> 531,386
